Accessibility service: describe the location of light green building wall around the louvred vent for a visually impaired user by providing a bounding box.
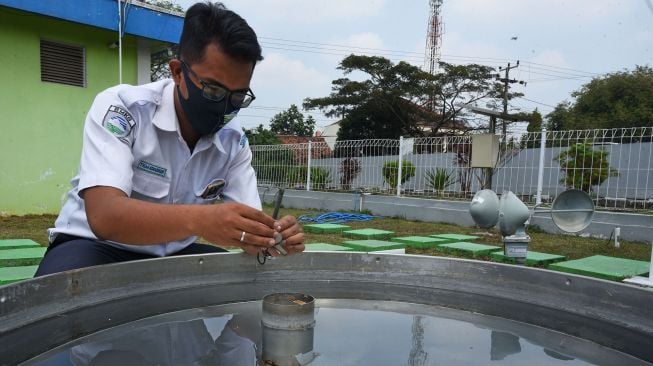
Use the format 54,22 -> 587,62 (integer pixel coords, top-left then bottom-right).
0,7 -> 137,214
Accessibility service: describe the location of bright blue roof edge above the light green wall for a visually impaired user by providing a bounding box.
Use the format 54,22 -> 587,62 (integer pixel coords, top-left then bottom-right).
0,0 -> 184,44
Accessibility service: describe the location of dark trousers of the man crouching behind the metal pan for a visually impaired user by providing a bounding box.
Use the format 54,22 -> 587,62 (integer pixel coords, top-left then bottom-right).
34,234 -> 226,277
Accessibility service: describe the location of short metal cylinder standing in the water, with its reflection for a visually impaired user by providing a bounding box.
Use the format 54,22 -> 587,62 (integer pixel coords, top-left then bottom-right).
261,293 -> 315,366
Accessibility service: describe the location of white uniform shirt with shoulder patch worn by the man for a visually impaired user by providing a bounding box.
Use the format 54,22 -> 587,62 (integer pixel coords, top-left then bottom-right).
48,79 -> 261,256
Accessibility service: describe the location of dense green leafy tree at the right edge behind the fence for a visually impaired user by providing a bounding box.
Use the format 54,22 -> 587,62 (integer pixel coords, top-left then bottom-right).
547,66 -> 653,130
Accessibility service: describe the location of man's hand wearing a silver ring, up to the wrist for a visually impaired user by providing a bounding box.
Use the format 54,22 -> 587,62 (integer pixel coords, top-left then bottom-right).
198,202 -> 278,254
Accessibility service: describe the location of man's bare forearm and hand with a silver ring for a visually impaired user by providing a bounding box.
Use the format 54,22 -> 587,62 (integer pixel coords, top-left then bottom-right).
80,186 -> 275,254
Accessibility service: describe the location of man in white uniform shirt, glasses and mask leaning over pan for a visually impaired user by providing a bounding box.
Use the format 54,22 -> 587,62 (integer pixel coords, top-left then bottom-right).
36,3 -> 304,276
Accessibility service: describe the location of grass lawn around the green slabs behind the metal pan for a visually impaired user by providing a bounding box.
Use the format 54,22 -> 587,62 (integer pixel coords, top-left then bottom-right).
0,206 -> 651,261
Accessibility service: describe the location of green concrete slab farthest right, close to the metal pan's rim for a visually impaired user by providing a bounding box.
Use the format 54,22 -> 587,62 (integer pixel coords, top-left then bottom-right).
548,255 -> 650,281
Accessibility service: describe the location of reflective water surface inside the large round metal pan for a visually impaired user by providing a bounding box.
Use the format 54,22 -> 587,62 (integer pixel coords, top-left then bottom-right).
29,300 -> 639,366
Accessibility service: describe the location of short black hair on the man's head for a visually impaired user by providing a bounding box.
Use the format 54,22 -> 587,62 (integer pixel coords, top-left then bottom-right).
178,1 -> 263,64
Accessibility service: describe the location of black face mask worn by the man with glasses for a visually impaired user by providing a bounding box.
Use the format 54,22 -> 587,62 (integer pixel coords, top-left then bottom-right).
177,68 -> 239,136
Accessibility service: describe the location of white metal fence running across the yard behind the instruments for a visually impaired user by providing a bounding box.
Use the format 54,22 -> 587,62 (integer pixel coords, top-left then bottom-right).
251,127 -> 653,211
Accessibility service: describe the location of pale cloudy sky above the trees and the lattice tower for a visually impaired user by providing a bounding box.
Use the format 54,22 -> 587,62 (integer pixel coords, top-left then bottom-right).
176,0 -> 653,130
